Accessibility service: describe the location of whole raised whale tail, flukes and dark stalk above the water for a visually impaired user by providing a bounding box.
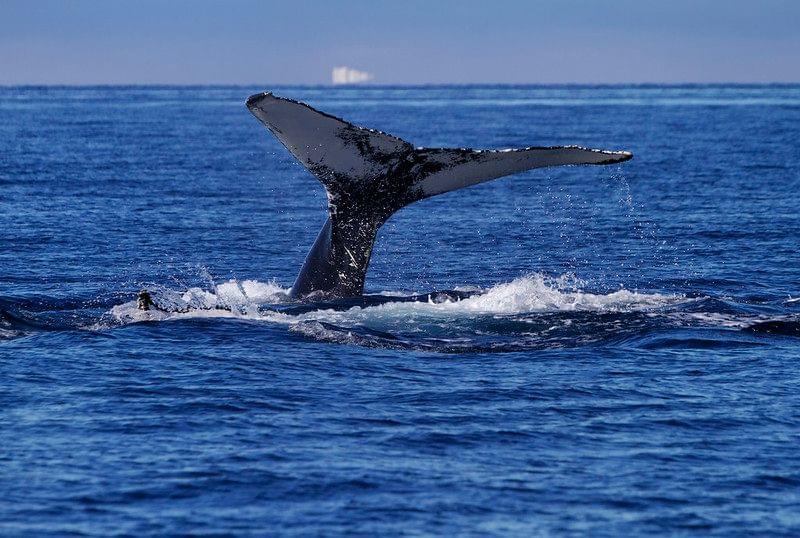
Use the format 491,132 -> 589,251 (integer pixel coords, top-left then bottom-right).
247,93 -> 632,298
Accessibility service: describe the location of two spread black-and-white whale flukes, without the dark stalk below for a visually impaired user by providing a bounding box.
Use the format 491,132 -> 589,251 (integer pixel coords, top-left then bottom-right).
247,93 -> 633,208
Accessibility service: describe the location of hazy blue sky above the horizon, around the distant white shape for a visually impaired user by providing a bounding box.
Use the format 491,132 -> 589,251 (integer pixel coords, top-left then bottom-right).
0,0 -> 800,84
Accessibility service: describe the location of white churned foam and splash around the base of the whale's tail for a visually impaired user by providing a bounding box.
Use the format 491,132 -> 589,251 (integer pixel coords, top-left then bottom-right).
98,274 -> 684,332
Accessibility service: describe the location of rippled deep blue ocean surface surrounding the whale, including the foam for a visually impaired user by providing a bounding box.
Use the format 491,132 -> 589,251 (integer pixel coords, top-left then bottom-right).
0,85 -> 800,536
